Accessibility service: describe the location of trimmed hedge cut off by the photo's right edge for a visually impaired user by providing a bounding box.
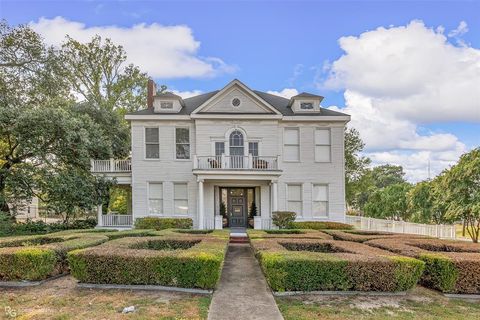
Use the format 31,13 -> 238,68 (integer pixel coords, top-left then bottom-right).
365,238 -> 480,294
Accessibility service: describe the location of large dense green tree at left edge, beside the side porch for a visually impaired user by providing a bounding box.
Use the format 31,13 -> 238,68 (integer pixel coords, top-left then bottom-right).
0,21 -> 128,217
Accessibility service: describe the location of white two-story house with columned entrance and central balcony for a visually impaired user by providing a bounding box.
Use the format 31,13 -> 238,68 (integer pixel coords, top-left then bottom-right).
92,80 -> 350,229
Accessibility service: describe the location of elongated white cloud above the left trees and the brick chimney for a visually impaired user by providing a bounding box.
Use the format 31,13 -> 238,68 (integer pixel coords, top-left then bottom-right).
30,17 -> 235,78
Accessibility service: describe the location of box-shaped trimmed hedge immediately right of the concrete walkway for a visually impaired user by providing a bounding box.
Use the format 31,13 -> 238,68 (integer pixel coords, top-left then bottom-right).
251,238 -> 425,291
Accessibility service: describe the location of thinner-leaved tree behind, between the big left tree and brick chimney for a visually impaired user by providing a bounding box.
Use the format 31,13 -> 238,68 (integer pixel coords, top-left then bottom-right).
62,36 -> 148,115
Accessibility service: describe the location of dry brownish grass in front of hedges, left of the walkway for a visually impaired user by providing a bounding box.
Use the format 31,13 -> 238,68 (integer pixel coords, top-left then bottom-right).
0,277 -> 211,320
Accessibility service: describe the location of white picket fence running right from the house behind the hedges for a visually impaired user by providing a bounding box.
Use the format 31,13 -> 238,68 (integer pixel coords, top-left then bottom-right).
346,216 -> 456,239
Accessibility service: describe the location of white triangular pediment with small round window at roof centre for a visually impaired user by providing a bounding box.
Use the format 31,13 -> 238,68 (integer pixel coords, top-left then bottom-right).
193,80 -> 280,115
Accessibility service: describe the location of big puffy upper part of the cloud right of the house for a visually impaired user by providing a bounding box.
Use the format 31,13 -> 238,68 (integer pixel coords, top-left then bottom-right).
322,21 -> 480,122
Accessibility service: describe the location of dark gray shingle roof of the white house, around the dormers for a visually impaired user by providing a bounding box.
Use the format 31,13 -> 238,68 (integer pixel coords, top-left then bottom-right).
129,90 -> 347,117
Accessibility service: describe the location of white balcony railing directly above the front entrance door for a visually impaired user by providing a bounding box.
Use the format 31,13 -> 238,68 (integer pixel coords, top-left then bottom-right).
193,155 -> 278,171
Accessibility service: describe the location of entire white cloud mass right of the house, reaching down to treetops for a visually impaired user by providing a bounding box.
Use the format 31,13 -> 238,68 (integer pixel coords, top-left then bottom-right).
318,21 -> 480,181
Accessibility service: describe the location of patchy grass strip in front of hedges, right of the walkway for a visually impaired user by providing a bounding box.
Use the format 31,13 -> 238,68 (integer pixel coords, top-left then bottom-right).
276,287 -> 480,320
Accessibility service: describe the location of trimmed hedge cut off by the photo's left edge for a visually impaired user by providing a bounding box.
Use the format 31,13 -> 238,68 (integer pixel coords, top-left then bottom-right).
0,233 -> 108,281
